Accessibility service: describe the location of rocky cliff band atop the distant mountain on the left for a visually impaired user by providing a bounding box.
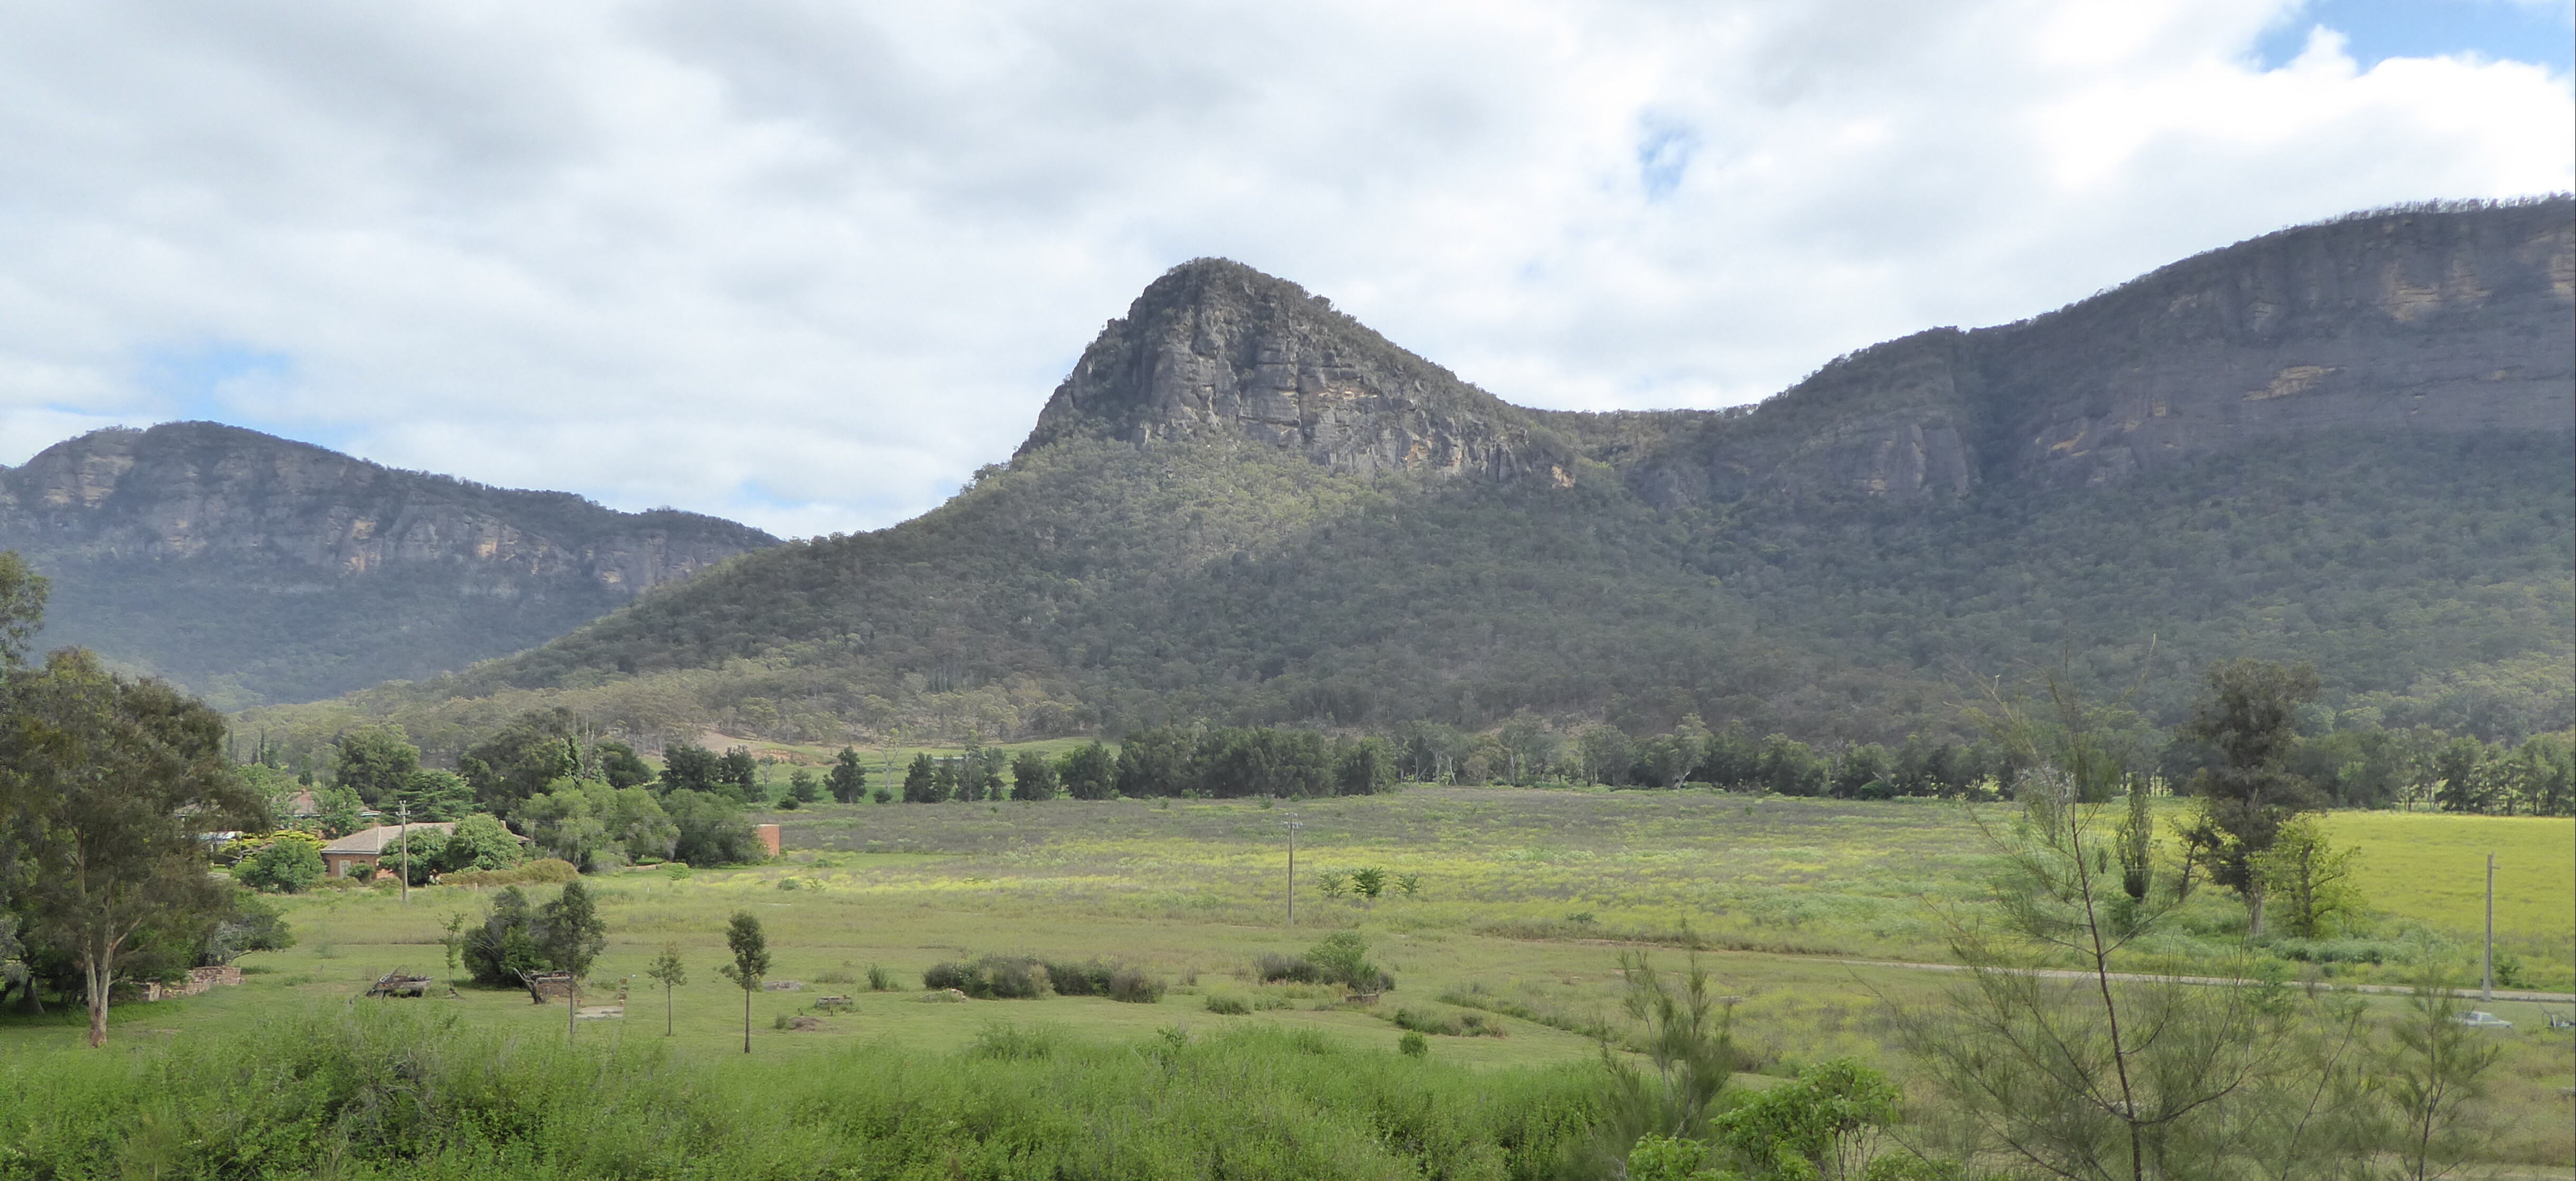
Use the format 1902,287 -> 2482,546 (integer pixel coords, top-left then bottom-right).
0,423 -> 778,598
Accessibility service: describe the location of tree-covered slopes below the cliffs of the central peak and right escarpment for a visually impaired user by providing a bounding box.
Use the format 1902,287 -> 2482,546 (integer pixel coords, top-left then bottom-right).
247,436 -> 2576,753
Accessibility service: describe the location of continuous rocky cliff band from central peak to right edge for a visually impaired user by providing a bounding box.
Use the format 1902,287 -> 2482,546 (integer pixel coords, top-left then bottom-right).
1023,199 -> 2576,505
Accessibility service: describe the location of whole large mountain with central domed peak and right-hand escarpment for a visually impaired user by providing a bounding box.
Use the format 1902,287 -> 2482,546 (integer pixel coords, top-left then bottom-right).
246,199 -> 2576,763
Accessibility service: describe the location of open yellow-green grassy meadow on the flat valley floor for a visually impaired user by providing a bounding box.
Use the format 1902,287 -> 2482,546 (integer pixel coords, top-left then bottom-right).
0,789 -> 2576,1176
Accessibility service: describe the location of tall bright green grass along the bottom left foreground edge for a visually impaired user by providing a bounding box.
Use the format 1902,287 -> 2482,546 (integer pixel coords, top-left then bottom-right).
0,1008 -> 1597,1178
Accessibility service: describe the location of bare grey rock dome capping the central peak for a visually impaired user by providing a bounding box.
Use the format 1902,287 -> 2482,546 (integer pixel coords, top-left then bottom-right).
1020,258 -> 1571,482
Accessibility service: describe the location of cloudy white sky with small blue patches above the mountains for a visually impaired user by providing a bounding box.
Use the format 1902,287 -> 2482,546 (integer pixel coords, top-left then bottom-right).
0,0 -> 2576,536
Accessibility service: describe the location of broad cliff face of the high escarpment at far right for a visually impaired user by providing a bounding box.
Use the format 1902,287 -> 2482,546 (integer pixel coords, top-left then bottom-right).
1968,199 -> 2576,487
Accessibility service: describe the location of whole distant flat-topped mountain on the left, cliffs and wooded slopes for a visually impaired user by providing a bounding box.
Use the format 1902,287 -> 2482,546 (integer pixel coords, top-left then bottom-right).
0,423 -> 778,709
